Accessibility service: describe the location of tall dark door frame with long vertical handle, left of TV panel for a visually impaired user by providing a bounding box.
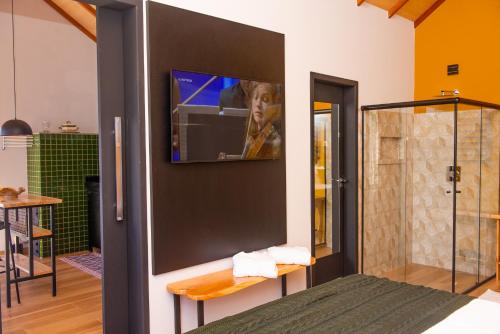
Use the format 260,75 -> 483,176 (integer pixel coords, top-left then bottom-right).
79,0 -> 149,334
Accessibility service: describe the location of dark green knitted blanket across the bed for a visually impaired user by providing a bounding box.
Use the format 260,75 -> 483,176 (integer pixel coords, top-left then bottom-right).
189,275 -> 472,334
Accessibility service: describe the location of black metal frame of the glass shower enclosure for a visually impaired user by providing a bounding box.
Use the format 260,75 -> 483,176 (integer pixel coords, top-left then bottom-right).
361,97 -> 500,294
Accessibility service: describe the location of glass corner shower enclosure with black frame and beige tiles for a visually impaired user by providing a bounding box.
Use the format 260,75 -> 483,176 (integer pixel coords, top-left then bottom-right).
361,97 -> 500,293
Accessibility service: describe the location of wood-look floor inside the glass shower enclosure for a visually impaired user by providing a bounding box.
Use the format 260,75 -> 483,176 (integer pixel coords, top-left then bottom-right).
382,263 -> 486,293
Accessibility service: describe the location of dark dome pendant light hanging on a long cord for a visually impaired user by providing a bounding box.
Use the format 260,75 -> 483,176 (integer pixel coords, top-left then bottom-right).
0,0 -> 33,150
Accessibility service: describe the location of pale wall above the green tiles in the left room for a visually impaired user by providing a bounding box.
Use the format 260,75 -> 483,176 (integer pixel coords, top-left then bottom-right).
0,0 -> 97,187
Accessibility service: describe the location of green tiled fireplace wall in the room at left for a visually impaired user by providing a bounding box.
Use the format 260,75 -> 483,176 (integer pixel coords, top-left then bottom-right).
28,134 -> 99,257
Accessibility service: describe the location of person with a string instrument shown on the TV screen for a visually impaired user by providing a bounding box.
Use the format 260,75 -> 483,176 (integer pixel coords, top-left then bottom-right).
242,82 -> 281,159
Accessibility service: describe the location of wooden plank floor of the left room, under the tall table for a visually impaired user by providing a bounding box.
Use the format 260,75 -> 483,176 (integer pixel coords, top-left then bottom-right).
0,260 -> 102,334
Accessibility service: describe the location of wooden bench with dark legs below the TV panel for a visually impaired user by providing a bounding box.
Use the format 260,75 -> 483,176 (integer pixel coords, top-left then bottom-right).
167,258 -> 316,334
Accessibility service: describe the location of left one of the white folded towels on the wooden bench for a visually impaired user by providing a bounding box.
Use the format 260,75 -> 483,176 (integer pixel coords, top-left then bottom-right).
233,251 -> 278,278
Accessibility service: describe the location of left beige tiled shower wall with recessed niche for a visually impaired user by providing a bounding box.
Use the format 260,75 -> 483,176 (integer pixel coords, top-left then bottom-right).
364,110 -> 412,275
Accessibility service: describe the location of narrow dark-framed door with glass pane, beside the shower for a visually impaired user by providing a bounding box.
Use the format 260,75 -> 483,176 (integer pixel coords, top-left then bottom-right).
311,73 -> 358,285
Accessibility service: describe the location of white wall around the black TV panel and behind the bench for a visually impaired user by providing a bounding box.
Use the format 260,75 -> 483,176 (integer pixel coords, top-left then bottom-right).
146,0 -> 414,333
